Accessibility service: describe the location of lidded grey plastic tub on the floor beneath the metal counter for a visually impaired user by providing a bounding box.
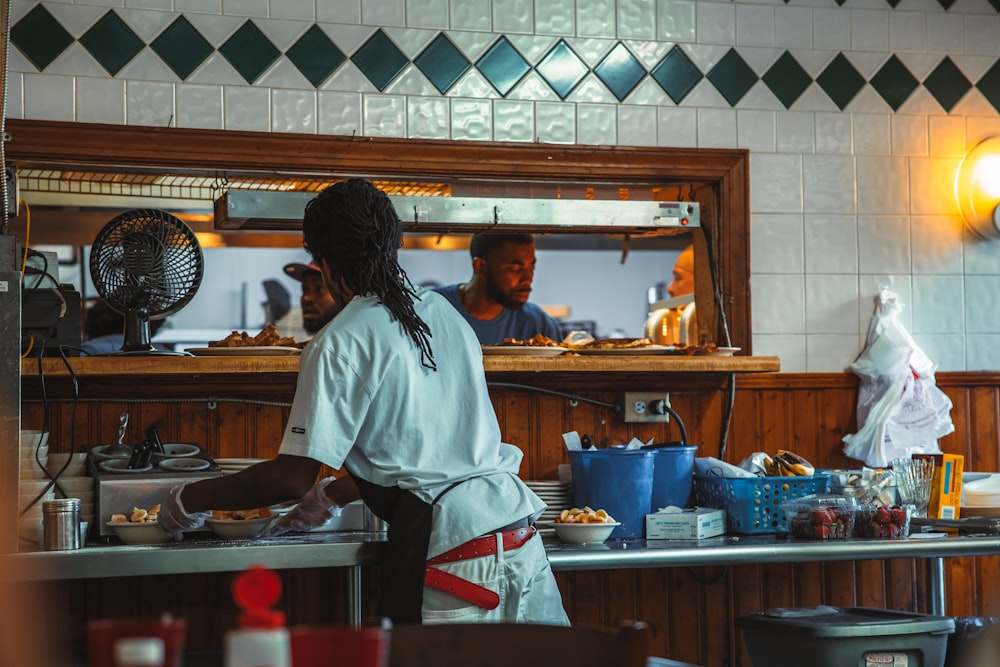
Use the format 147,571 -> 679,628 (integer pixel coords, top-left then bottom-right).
736,606 -> 955,667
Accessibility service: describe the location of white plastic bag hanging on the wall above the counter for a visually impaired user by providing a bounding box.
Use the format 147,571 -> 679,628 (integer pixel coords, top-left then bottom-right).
844,286 -> 955,468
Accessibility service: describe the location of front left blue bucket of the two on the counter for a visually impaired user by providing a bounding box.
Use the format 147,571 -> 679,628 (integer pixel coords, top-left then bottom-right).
569,449 -> 656,538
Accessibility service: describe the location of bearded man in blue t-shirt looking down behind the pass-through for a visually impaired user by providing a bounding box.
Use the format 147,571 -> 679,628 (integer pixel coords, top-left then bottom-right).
434,232 -> 562,345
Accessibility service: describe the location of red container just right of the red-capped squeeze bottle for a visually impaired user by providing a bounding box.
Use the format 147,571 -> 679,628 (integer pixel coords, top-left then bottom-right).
288,623 -> 392,667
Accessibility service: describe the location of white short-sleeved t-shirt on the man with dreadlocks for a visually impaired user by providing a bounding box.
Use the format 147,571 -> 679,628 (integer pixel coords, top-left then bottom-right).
280,288 -> 545,557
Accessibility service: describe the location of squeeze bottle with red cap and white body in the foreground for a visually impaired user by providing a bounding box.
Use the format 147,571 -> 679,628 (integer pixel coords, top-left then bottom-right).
225,565 -> 292,667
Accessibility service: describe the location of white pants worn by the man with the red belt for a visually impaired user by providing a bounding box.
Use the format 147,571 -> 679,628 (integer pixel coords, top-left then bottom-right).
421,533 -> 569,625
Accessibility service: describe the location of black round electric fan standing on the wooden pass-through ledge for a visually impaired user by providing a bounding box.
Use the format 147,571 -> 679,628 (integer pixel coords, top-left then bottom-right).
90,209 -> 204,355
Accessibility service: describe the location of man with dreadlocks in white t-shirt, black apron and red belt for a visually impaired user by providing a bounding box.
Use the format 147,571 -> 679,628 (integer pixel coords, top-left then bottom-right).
159,178 -> 568,625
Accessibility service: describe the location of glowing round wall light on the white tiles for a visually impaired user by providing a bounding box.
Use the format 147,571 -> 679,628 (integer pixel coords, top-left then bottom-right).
955,137 -> 1000,241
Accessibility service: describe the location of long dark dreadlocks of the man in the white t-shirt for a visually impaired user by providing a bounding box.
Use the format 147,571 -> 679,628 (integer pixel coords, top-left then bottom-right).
302,178 -> 437,370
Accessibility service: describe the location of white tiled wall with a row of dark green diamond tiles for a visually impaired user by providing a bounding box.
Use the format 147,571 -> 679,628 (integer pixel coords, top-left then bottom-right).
8,0 -> 1000,372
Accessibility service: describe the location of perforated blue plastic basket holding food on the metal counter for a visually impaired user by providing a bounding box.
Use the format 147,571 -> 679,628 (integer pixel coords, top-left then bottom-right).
694,474 -> 830,535
